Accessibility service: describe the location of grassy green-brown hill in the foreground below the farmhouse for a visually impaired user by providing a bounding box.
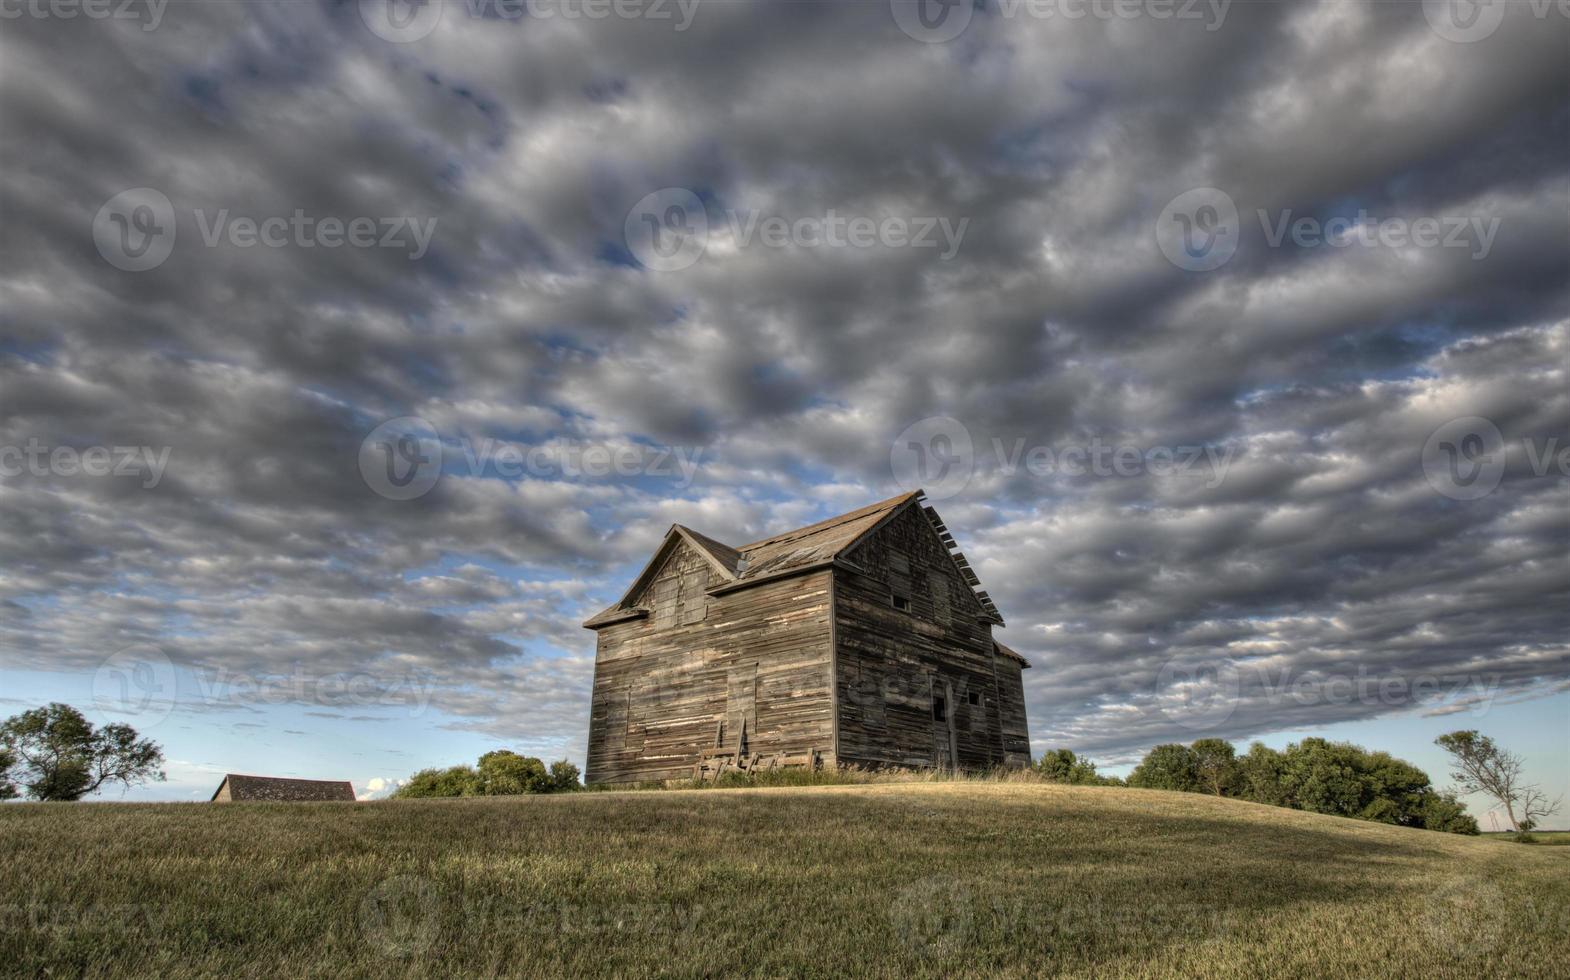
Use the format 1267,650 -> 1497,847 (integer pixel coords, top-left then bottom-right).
0,782 -> 1570,977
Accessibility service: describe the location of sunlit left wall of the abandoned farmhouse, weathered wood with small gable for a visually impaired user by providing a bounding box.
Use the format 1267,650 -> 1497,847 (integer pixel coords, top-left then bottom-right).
584,542 -> 834,784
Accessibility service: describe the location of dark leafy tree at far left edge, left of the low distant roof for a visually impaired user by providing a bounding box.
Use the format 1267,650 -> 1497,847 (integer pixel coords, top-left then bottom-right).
0,702 -> 165,801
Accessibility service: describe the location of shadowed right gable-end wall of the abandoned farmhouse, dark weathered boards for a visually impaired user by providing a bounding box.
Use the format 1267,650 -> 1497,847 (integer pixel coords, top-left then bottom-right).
834,507 -> 1030,770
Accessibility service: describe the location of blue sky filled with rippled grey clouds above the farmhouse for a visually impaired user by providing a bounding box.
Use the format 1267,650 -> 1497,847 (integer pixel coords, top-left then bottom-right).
0,0 -> 1570,798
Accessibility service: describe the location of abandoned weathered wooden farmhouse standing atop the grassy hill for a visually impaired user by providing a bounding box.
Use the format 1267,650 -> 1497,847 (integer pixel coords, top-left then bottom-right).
584,492 -> 1030,784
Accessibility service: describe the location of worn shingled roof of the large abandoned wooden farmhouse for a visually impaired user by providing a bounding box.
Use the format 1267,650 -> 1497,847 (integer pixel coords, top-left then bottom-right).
584,490 -> 1004,628
